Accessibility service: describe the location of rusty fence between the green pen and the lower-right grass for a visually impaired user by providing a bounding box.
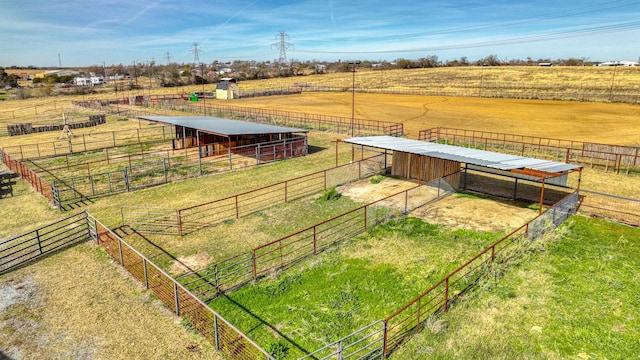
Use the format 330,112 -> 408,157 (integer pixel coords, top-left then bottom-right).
384,191 -> 579,356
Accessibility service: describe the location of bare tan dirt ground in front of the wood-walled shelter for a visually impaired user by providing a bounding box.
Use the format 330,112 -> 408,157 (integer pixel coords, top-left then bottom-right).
337,178 -> 537,232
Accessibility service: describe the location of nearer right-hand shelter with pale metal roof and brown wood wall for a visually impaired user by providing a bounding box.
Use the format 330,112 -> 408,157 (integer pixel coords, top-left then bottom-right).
343,136 -> 582,209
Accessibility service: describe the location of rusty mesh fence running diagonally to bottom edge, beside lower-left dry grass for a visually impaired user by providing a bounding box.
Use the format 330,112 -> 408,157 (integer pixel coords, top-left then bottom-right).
86,213 -> 274,360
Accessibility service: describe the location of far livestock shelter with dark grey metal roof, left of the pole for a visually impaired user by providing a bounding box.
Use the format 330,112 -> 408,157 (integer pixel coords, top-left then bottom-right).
138,116 -> 309,160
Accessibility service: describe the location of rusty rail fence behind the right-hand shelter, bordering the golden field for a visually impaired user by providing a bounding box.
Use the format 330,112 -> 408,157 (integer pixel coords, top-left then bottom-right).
418,127 -> 640,173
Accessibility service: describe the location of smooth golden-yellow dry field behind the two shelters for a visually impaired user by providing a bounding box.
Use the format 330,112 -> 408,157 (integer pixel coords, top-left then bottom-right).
230,93 -> 640,145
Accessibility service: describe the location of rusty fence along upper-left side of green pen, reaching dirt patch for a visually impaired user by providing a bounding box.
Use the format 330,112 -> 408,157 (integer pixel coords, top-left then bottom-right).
178,179 -> 454,299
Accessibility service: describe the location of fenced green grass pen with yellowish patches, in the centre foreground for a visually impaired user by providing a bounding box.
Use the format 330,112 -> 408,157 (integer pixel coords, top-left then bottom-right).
211,218 -> 501,359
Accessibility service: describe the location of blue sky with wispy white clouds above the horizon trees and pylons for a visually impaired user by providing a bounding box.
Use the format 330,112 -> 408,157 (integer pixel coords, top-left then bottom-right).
0,0 -> 640,66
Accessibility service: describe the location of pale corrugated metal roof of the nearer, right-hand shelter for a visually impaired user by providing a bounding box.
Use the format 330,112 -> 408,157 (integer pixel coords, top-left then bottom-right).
343,135 -> 582,174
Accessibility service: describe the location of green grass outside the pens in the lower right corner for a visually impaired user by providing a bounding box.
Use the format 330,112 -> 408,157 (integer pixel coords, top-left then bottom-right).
391,216 -> 640,359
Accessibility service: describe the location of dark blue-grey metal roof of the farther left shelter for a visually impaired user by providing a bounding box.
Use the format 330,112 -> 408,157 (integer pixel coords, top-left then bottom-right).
138,116 -> 309,136
